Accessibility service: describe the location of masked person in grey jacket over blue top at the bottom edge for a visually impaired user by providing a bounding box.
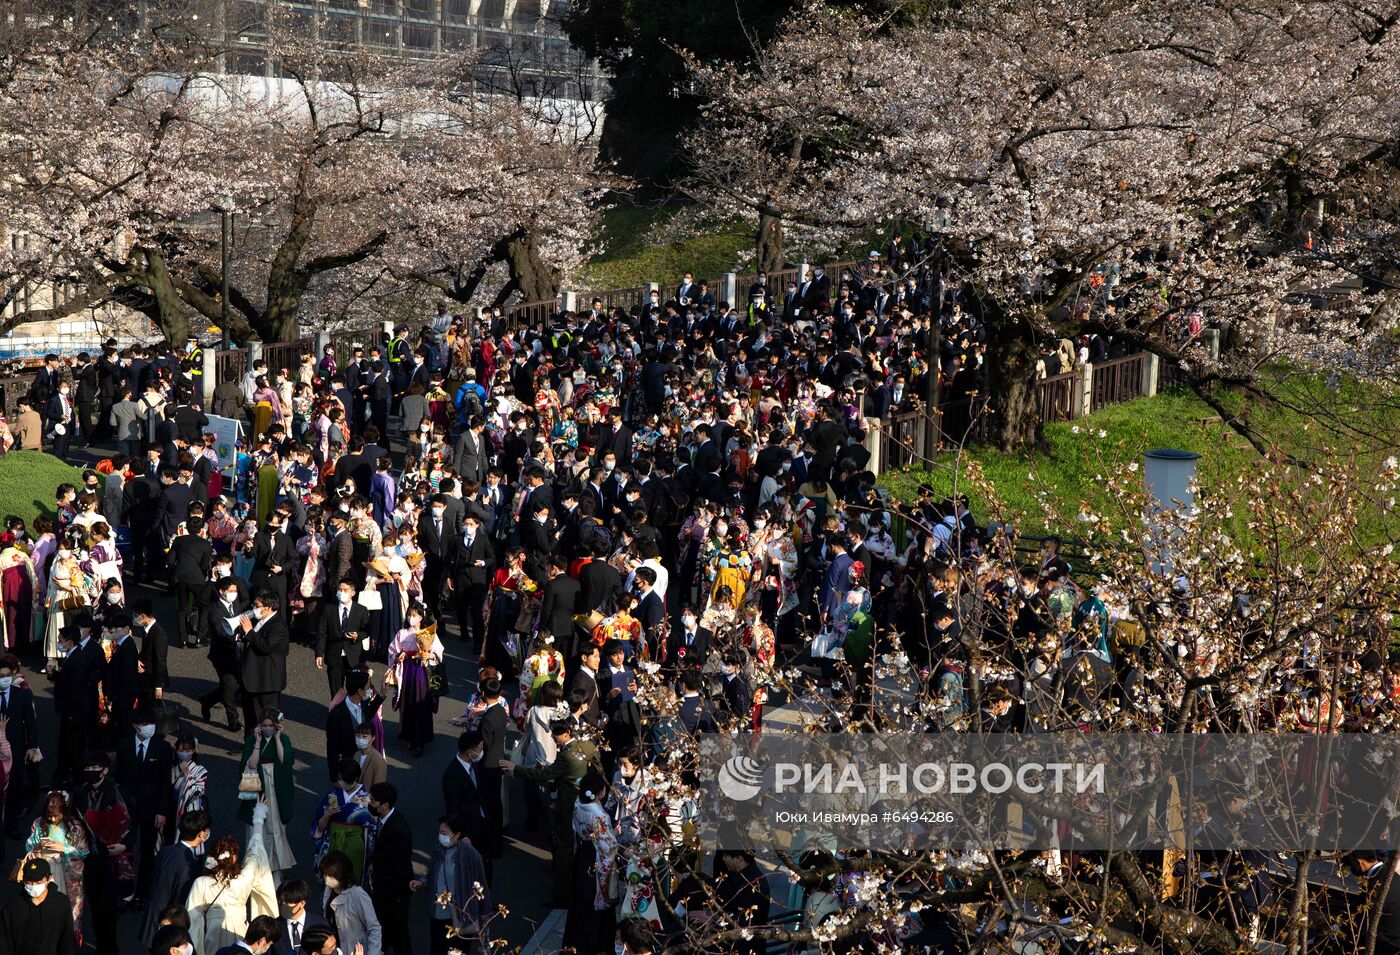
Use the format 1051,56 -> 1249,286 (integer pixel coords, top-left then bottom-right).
409,815 -> 493,955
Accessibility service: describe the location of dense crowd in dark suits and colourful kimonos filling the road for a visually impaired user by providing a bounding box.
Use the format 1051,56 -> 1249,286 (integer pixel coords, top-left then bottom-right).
0,244 -> 1338,955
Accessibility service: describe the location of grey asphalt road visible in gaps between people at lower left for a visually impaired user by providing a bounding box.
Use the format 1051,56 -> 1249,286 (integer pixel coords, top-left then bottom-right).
0,436 -> 550,955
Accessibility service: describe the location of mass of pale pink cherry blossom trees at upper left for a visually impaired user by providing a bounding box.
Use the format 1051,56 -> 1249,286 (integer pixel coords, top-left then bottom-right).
0,0 -> 602,340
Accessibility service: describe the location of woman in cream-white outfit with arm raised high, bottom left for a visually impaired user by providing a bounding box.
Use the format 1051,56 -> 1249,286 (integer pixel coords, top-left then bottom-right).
185,798 -> 277,955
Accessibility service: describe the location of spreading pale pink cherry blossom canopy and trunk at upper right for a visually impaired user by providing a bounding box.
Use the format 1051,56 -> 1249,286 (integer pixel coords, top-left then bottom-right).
690,0 -> 1400,449
